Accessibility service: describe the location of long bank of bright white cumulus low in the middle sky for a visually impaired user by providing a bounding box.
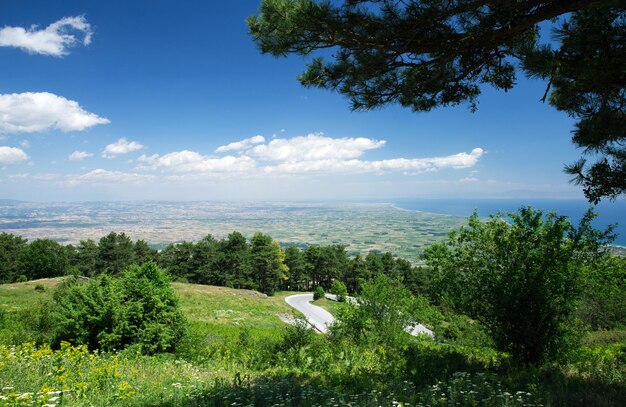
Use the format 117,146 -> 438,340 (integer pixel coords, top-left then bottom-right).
136,134 -> 484,176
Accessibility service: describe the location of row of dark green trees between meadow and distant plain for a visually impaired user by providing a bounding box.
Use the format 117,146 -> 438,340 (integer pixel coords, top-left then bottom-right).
0,232 -> 428,294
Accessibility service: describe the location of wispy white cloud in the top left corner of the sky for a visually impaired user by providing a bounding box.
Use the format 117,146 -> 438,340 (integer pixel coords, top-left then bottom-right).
0,16 -> 93,57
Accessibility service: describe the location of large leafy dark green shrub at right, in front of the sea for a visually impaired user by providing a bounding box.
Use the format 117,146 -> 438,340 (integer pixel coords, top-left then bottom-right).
424,207 -> 611,364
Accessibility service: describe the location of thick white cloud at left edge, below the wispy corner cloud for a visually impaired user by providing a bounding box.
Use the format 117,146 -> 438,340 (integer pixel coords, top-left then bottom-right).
0,92 -> 109,133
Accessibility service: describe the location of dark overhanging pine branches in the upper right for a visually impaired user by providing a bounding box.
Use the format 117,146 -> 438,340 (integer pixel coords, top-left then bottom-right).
248,0 -> 626,202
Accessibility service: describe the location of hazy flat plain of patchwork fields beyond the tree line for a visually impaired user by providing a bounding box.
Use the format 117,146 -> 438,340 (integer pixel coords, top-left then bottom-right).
0,201 -> 466,262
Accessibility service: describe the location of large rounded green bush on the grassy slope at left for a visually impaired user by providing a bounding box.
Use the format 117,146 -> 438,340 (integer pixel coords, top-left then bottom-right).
52,263 -> 186,354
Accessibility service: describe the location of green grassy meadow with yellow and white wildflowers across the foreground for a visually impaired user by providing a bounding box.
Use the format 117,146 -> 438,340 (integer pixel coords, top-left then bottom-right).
0,278 -> 626,407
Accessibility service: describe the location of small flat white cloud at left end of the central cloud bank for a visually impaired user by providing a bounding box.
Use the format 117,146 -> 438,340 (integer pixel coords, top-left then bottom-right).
137,150 -> 256,173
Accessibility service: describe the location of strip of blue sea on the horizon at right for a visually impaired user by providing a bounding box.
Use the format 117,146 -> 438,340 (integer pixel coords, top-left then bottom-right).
392,199 -> 626,246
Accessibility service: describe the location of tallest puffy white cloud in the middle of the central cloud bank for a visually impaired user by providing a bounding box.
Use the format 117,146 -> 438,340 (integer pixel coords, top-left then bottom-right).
245,133 -> 385,162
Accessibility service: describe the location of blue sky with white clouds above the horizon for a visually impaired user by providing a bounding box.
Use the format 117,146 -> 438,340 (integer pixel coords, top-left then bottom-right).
0,0 -> 596,201
